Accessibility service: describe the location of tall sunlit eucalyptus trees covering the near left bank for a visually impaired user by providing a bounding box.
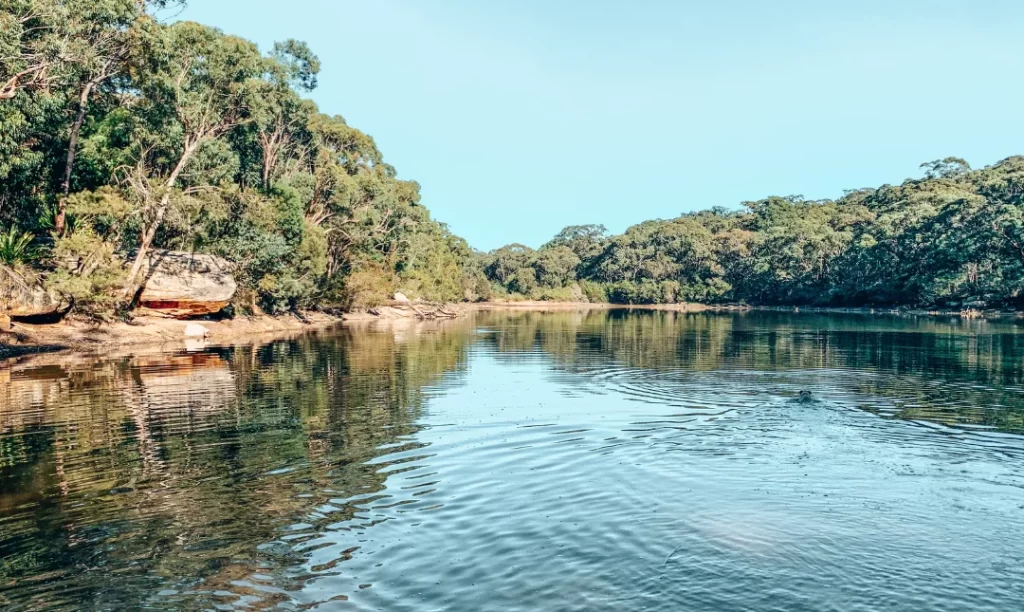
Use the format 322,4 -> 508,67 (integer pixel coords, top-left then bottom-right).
0,0 -> 486,313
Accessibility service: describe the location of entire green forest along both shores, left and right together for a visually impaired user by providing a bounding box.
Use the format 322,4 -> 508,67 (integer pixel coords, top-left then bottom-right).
6,0 -> 1024,315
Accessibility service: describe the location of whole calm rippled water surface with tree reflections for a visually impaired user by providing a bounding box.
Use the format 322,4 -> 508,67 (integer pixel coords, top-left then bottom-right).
0,311 -> 1024,612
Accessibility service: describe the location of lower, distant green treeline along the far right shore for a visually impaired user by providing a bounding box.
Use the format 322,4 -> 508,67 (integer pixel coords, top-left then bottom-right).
482,157 -> 1024,308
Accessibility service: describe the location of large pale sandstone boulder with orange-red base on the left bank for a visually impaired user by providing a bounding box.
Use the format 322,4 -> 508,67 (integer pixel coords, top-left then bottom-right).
138,251 -> 238,318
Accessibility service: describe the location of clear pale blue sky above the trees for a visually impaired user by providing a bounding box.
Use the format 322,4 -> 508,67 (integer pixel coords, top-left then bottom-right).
183,0 -> 1024,250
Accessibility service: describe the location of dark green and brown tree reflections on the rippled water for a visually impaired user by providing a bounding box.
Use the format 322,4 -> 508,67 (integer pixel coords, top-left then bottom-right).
0,311 -> 1024,609
